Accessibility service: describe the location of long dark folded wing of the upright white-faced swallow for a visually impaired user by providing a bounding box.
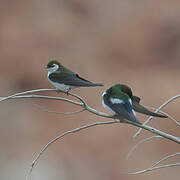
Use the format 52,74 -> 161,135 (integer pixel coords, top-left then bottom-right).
49,73 -> 103,87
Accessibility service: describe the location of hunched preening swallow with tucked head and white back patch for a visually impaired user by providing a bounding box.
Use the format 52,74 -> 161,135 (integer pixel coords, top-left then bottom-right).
103,84 -> 167,123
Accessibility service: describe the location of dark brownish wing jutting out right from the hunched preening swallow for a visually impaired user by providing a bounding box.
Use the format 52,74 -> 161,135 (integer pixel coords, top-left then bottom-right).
132,96 -> 167,118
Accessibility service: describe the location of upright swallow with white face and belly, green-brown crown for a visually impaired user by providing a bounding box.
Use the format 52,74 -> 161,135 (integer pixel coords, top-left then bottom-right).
46,60 -> 103,93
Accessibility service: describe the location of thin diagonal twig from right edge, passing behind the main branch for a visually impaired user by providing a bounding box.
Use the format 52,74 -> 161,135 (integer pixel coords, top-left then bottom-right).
133,94 -> 180,138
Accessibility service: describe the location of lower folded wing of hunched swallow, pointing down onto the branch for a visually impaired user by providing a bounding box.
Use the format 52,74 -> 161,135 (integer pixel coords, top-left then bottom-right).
104,99 -> 141,124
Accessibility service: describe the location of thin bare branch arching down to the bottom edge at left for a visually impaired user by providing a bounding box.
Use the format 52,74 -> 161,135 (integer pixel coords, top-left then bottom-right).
26,120 -> 120,180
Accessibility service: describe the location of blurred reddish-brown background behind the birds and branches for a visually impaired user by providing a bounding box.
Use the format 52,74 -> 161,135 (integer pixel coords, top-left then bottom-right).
0,0 -> 180,180
